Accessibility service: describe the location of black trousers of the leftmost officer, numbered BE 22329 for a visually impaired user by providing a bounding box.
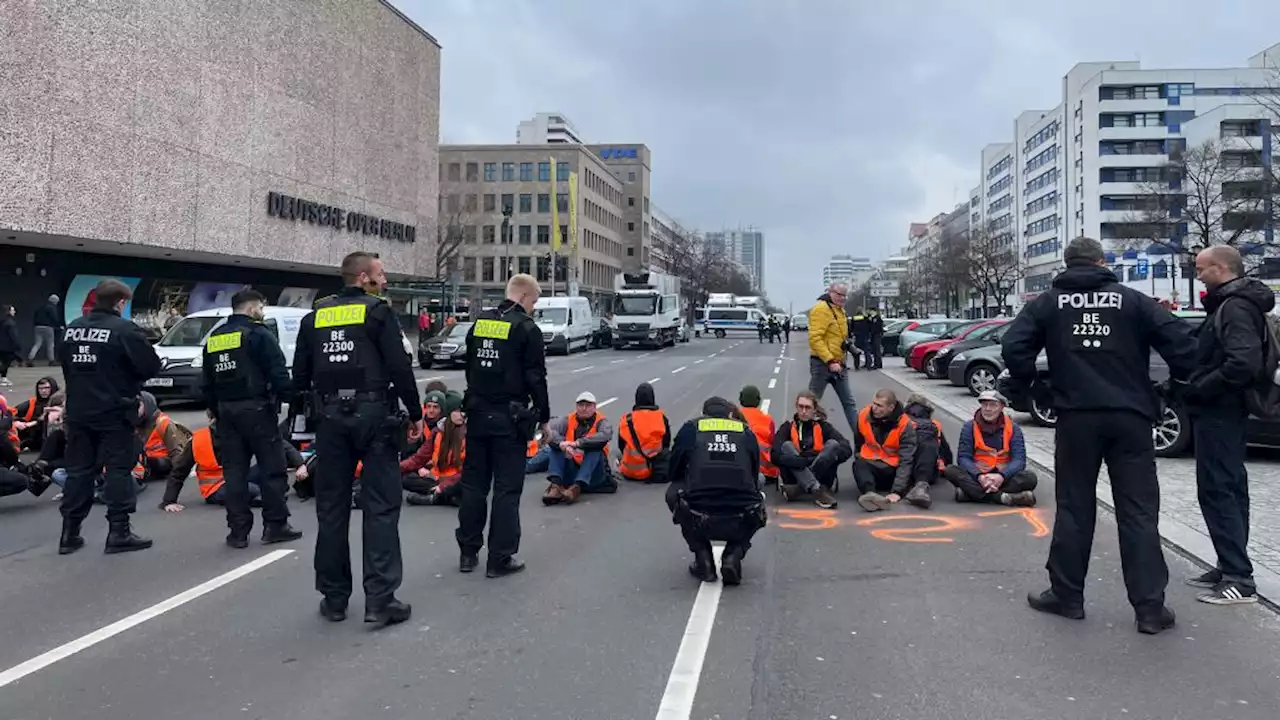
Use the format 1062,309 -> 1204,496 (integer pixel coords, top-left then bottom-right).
61,416 -> 138,527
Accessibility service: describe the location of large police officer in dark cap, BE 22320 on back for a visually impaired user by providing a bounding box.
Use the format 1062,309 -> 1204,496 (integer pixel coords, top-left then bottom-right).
1002,237 -> 1196,634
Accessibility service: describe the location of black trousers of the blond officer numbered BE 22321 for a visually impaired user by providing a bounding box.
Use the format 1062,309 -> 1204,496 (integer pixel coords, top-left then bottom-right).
456,410 -> 527,568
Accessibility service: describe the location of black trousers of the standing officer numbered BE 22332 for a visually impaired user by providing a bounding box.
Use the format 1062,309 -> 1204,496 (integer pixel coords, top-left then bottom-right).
214,400 -> 289,537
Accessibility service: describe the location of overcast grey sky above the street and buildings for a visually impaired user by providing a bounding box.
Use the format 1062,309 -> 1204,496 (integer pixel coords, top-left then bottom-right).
393,0 -> 1280,307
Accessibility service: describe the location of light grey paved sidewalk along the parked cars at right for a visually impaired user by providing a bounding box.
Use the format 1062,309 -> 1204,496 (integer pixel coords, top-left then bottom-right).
882,359 -> 1280,605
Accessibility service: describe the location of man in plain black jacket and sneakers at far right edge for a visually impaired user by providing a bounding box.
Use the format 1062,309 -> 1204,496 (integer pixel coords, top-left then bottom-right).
1183,245 -> 1275,605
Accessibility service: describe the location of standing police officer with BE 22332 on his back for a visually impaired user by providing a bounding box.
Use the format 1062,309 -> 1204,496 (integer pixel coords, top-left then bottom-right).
202,290 -> 302,548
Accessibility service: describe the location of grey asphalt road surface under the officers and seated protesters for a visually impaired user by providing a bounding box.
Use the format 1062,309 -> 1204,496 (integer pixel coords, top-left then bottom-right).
0,334 -> 1280,720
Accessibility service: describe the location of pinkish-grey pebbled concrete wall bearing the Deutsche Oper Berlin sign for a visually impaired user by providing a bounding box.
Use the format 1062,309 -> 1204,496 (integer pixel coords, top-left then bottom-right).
0,0 -> 440,275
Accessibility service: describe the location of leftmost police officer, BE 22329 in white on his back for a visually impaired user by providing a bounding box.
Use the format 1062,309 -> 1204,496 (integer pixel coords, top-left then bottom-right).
58,279 -> 160,555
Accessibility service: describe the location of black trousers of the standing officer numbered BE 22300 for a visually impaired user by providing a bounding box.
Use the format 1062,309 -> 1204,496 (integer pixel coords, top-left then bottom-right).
315,401 -> 404,609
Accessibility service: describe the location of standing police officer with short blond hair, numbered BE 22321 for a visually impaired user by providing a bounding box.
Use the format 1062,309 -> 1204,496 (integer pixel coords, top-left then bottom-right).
457,274 -> 552,578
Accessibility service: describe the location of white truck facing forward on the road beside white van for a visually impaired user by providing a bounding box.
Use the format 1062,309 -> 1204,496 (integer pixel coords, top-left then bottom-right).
611,272 -> 685,350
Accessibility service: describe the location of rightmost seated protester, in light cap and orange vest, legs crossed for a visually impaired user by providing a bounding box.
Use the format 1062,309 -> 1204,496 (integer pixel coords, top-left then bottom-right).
942,389 -> 1037,507
